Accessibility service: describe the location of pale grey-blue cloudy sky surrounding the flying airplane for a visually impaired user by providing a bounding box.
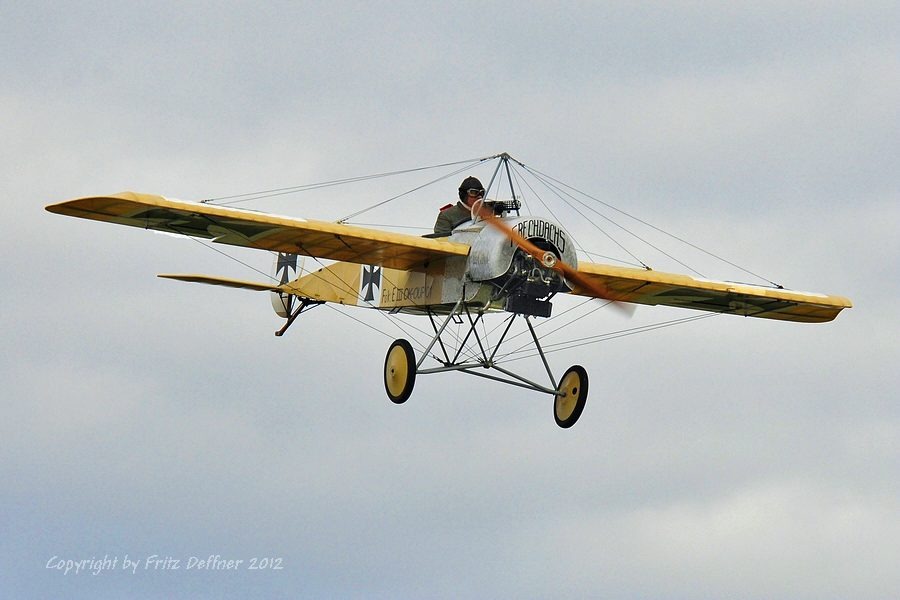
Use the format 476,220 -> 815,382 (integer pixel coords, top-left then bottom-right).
0,1 -> 900,598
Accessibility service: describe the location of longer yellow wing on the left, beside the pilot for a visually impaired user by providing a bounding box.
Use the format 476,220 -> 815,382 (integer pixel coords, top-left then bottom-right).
47,192 -> 469,270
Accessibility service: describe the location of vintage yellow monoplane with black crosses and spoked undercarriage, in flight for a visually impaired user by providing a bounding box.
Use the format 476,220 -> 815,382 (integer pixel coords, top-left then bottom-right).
47,154 -> 851,428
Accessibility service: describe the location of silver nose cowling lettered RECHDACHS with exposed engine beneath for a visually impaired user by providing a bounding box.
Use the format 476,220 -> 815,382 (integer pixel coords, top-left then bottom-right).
469,217 -> 578,317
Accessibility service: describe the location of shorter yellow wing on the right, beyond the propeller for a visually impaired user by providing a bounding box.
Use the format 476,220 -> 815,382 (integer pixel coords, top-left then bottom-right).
573,262 -> 851,323
